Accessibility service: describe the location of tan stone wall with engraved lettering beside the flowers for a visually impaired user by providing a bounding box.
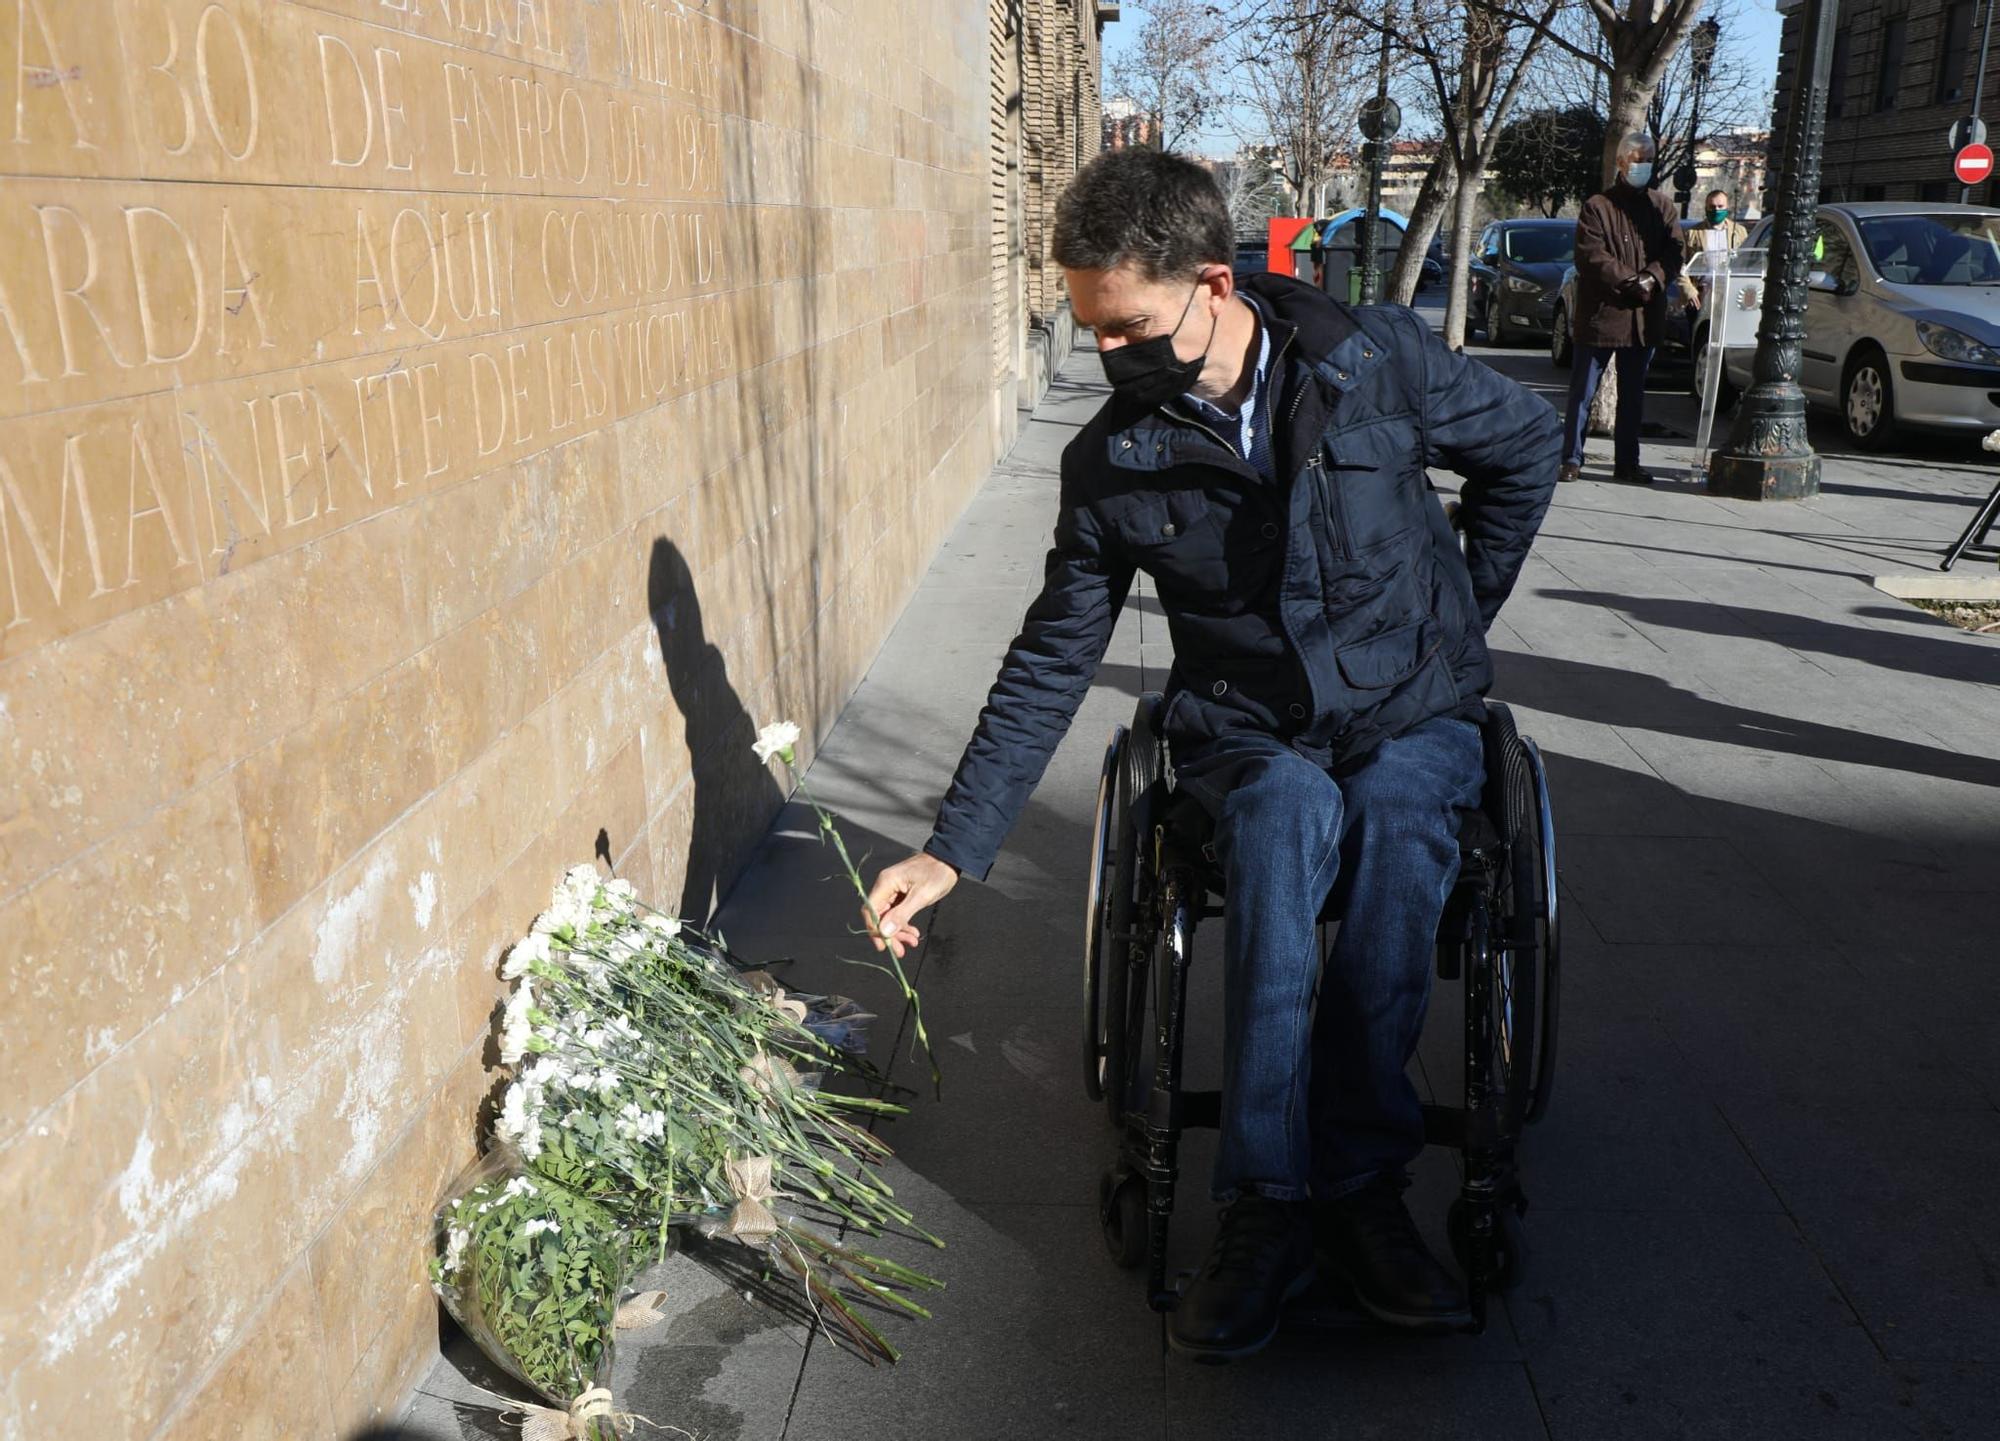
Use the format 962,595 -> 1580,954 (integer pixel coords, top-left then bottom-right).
0,0 -> 1024,1441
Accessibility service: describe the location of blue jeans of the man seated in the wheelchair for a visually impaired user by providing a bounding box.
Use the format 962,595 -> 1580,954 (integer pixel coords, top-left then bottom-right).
1176,718 -> 1484,1203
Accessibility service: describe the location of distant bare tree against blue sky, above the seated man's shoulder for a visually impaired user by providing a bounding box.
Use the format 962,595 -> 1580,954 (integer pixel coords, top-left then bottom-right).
1230,0 -> 1374,216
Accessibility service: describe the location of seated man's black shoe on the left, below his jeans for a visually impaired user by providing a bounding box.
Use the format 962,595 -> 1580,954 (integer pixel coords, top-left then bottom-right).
1166,1195 -> 1312,1361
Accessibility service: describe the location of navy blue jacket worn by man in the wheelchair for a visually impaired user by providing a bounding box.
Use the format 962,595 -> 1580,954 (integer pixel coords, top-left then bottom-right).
924,274 -> 1562,881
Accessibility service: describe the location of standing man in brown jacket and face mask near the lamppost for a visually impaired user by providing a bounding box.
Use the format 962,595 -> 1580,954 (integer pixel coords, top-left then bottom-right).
1560,132 -> 1682,484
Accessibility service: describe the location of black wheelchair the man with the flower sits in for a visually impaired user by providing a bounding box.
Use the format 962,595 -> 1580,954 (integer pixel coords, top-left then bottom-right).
1084,692 -> 1560,1331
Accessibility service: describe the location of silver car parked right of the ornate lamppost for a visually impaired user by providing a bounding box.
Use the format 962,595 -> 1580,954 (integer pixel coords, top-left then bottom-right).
1720,200 -> 2000,448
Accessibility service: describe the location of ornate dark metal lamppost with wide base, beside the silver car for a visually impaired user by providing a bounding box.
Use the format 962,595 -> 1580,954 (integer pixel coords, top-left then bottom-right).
1708,0 -> 1840,500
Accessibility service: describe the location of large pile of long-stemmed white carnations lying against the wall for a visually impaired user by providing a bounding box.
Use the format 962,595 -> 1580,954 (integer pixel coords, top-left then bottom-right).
498,867 -> 938,1359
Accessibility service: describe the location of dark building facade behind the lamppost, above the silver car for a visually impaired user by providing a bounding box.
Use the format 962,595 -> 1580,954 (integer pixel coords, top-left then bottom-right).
1764,0 -> 2000,210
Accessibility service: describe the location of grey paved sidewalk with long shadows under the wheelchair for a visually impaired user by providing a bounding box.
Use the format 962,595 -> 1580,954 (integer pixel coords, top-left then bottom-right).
410,326 -> 2000,1441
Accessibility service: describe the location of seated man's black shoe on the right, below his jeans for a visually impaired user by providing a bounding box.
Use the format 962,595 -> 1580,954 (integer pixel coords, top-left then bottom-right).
1312,1177 -> 1472,1331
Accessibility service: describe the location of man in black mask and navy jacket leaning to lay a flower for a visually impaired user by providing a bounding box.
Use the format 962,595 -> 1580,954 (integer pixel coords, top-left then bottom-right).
872,150 -> 1562,1359
